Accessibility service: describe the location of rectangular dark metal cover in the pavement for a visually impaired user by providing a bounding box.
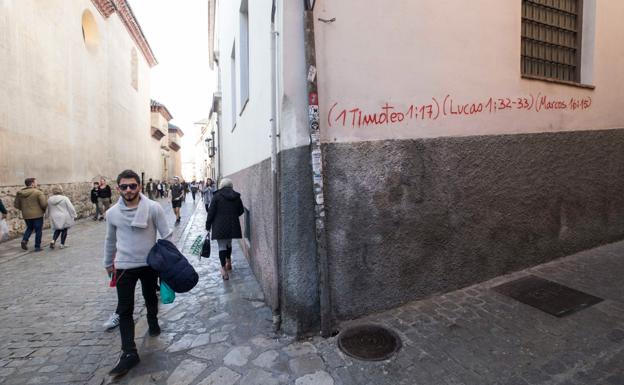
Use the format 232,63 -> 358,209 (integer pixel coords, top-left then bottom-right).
492,275 -> 602,317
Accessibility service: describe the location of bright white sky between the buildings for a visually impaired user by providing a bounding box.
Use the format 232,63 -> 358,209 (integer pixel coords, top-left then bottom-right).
128,0 -> 216,163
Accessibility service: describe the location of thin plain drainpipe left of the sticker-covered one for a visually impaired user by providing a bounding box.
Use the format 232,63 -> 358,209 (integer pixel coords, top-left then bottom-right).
271,0 -> 282,331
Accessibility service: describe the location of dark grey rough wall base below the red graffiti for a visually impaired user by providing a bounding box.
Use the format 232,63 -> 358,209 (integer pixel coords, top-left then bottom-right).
324,130 -> 624,319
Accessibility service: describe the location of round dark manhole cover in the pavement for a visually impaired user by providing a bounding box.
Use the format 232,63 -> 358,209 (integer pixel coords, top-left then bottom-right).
338,325 -> 401,361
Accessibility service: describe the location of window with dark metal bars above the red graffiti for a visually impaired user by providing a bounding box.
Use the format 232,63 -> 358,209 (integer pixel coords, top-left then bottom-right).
521,0 -> 583,83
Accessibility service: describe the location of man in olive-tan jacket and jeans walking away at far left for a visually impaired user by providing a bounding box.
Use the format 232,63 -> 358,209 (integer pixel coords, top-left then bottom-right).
14,178 -> 48,251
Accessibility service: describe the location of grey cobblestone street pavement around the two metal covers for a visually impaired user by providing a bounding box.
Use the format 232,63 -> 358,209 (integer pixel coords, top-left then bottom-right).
0,194 -> 624,385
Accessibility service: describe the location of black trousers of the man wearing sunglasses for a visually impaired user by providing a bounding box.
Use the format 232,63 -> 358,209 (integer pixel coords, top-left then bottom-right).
116,266 -> 158,353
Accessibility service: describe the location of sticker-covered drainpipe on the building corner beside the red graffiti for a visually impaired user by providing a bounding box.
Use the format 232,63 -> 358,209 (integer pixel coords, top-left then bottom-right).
304,0 -> 333,338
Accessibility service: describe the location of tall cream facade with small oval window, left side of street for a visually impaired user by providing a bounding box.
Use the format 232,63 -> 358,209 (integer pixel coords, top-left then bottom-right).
0,0 -> 162,236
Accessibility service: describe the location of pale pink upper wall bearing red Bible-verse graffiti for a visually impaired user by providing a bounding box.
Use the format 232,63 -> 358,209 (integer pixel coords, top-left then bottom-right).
315,0 -> 624,142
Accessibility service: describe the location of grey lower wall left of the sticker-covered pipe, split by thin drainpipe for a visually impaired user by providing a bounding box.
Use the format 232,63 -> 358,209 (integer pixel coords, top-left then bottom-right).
228,147 -> 320,336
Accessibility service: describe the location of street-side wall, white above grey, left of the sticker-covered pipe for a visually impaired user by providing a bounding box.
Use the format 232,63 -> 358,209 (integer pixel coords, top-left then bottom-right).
217,0 -> 319,334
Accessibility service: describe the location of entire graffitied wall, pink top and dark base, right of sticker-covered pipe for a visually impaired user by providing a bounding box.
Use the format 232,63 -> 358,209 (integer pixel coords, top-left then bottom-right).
314,0 -> 624,319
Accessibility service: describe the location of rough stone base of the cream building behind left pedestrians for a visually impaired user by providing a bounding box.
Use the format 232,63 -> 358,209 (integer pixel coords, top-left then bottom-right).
0,182 -> 118,239
